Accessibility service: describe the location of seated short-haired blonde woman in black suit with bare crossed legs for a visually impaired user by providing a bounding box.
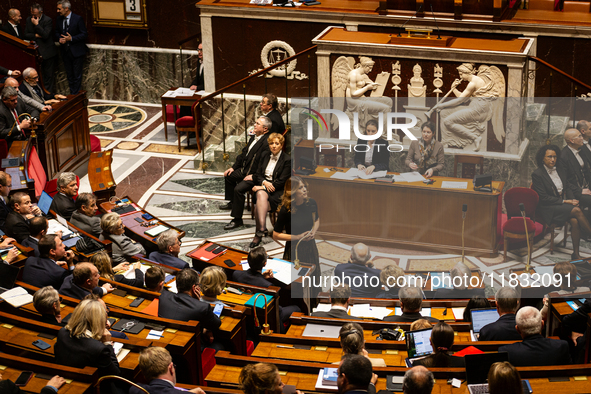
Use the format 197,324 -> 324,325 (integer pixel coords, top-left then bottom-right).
250,133 -> 291,249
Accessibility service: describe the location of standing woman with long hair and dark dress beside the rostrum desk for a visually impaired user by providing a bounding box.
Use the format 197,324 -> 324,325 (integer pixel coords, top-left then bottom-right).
273,176 -> 320,297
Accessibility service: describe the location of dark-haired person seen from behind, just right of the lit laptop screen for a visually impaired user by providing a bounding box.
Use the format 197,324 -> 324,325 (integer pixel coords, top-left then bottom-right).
413,322 -> 466,368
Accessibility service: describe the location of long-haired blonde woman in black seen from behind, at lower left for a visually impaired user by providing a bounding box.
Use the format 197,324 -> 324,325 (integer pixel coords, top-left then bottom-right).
55,299 -> 120,377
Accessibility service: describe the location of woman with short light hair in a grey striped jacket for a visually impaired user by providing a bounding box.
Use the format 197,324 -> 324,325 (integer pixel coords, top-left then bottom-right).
99,212 -> 146,264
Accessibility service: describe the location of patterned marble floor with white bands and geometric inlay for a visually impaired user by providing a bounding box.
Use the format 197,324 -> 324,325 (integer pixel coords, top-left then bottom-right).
77,100 -> 591,295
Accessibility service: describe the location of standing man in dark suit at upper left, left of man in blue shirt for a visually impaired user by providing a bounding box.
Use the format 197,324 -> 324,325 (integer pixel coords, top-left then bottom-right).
23,3 -> 57,93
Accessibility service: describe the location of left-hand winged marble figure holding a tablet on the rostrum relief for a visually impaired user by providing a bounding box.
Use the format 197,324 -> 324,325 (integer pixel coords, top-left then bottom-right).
332,56 -> 392,130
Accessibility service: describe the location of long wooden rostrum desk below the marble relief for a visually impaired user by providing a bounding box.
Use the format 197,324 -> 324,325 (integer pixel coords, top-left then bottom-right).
303,166 -> 505,257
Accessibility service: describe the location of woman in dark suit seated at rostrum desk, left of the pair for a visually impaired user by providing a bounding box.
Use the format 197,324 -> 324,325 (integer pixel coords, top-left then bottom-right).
355,119 -> 390,175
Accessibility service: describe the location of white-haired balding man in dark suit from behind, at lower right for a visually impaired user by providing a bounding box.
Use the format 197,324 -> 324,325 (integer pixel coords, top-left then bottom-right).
499,306 -> 571,367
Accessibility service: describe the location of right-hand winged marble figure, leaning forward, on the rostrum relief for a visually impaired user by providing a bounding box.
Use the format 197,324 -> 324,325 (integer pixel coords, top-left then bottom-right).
431,63 -> 505,151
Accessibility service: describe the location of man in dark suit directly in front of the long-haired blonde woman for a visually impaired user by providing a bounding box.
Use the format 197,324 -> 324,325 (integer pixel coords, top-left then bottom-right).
60,263 -> 115,300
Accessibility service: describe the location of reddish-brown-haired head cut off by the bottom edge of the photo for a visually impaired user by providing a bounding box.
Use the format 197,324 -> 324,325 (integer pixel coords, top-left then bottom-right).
238,363 -> 303,394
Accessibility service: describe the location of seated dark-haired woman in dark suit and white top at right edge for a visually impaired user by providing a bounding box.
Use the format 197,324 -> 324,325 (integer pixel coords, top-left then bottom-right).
531,145 -> 591,260
